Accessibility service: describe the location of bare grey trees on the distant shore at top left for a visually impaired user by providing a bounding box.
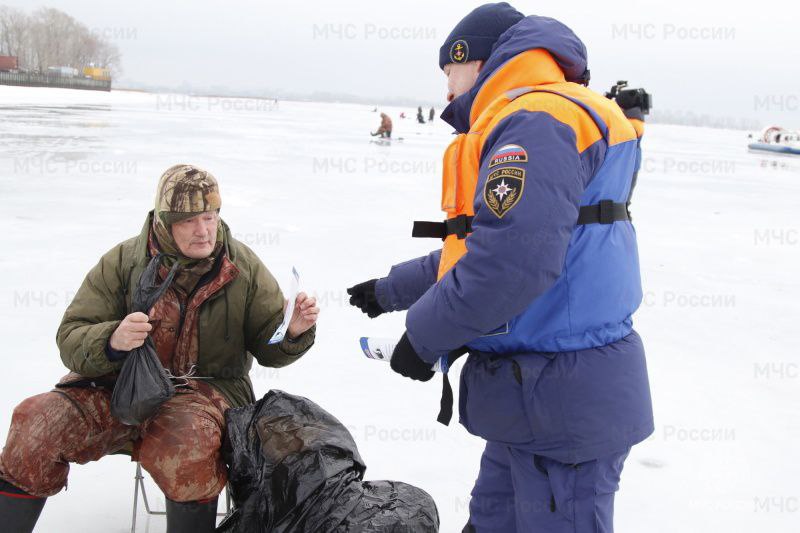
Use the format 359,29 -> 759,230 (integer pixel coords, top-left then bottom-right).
0,5 -> 120,73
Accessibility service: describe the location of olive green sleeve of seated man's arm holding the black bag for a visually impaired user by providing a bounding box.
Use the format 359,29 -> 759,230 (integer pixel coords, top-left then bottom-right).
56,246 -> 125,377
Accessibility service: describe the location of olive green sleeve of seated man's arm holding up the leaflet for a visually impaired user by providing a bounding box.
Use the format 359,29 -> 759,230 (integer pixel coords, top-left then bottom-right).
244,260 -> 316,367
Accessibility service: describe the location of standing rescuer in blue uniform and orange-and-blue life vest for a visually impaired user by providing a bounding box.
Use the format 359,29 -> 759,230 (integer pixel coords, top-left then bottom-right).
348,3 -> 654,533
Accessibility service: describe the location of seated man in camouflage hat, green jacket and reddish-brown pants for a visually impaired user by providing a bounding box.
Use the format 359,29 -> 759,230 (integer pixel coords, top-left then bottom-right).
0,165 -> 319,533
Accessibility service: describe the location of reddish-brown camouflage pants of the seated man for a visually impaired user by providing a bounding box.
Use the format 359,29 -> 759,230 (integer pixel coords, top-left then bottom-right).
0,380 -> 229,502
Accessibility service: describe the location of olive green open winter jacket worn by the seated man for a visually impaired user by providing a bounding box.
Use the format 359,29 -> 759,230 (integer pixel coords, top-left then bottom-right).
56,211 -> 316,407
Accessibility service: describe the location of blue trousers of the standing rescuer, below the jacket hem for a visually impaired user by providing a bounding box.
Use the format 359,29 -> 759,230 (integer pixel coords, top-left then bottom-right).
464,442 -> 630,533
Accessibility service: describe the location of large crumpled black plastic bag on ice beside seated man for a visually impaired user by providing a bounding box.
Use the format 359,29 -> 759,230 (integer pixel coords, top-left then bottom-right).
217,390 -> 439,533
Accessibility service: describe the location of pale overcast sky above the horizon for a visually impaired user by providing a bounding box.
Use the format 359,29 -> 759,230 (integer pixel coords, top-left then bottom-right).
0,0 -> 800,128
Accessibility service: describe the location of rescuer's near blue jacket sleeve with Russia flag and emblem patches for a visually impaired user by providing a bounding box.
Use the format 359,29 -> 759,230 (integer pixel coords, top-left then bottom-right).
406,111 -> 587,363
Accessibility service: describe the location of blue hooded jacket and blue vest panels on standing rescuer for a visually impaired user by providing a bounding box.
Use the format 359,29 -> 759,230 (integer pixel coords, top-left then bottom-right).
376,16 -> 653,463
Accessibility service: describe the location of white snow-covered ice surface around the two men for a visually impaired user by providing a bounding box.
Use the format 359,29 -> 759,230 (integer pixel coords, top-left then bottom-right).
0,87 -> 800,533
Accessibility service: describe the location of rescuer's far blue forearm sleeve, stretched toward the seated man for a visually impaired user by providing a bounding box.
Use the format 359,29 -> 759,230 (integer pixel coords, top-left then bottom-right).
375,249 -> 442,311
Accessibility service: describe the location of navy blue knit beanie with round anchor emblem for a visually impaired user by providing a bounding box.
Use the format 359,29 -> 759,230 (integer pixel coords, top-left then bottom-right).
439,2 -> 525,69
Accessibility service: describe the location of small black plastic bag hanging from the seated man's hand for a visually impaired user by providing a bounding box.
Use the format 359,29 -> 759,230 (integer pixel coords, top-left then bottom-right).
111,254 -> 178,426
